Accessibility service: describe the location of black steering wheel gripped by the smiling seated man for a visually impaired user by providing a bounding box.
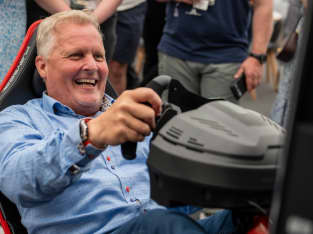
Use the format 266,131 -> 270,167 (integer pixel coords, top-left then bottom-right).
121,75 -> 179,160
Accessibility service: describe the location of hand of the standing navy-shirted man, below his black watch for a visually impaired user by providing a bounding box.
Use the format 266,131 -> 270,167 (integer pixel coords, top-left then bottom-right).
234,57 -> 263,92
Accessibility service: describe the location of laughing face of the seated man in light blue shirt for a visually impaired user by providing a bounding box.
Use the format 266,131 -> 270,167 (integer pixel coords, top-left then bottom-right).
36,23 -> 108,116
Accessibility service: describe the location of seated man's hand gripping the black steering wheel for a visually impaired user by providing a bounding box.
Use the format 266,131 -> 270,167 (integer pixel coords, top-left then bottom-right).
88,88 -> 162,148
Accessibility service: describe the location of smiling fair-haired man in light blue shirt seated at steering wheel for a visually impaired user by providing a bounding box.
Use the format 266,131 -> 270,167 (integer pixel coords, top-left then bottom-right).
0,10 -> 234,234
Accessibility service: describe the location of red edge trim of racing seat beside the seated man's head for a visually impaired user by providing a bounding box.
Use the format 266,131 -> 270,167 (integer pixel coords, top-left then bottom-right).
0,20 -> 41,92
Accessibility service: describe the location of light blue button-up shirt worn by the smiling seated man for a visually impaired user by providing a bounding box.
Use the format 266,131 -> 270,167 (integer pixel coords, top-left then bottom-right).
0,94 -> 164,234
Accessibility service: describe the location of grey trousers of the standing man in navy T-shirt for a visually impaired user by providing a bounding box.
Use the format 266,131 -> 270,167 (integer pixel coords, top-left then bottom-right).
159,52 -> 240,103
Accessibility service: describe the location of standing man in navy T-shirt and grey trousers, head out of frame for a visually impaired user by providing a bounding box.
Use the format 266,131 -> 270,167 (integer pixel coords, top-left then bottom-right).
158,0 -> 273,102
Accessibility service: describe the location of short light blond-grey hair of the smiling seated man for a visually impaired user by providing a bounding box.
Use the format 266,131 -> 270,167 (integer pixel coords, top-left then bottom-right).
36,10 -> 102,57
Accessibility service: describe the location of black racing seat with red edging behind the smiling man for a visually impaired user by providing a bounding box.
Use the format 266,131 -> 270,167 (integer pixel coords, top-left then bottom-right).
0,20 -> 117,234
